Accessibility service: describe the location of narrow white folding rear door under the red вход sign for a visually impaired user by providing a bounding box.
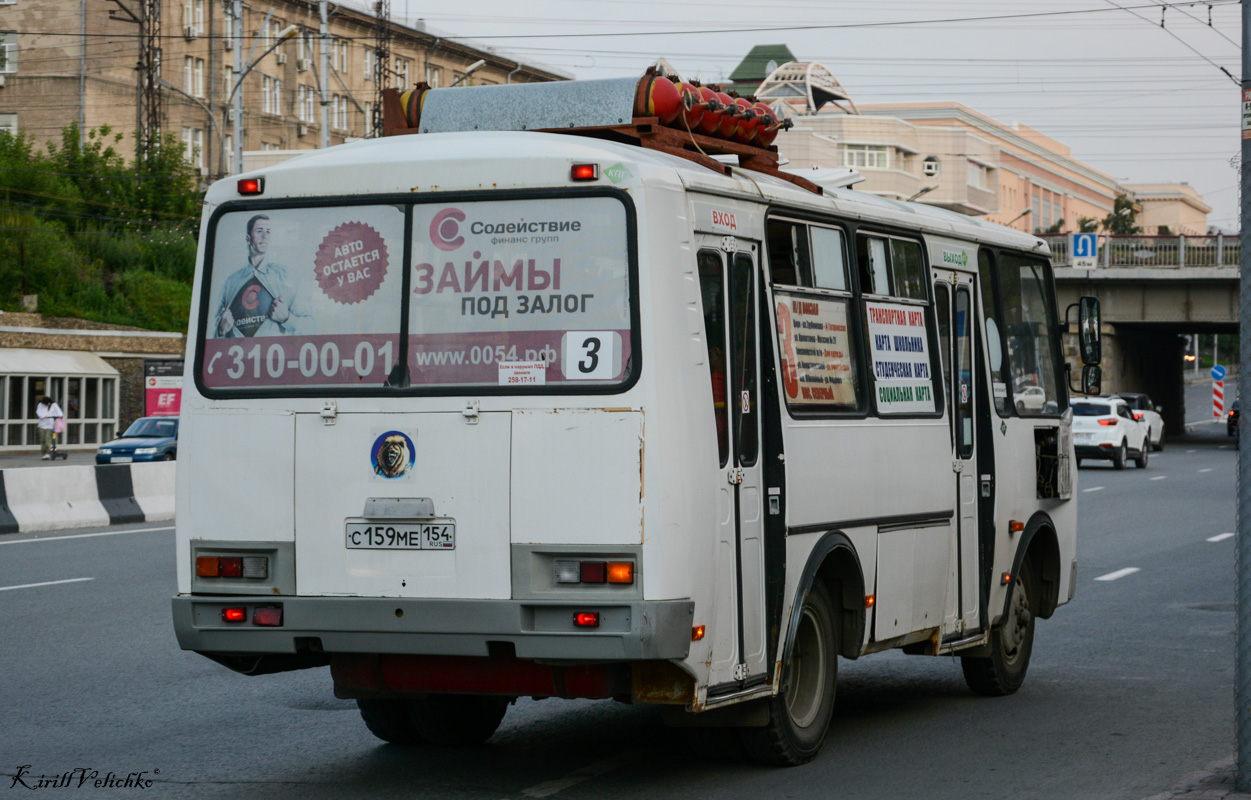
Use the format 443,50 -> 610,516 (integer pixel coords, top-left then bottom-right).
697,237 -> 768,694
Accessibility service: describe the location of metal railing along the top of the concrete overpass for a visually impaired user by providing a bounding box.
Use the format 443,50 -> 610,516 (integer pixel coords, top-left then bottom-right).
1040,233 -> 1241,269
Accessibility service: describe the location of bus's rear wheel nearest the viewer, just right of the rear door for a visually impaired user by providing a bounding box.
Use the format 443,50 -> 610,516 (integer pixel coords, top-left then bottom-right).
739,580 -> 838,766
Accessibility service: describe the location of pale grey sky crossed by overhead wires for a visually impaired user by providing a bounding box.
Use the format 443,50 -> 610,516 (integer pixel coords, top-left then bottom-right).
344,0 -> 1241,230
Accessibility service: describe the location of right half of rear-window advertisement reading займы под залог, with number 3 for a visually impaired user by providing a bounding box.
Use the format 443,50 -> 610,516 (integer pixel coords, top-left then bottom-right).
408,197 -> 631,389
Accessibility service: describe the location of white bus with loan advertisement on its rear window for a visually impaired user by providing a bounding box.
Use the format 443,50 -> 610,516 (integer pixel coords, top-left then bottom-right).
173,73 -> 1098,764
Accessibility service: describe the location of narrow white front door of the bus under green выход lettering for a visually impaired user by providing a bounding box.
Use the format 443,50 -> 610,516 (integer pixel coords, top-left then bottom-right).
934,272 -> 986,635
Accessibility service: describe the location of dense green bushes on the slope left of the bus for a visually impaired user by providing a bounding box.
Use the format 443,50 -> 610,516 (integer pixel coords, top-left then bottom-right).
0,124 -> 203,332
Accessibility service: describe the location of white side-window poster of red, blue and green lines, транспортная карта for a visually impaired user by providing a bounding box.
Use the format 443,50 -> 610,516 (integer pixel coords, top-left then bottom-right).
864,303 -> 934,414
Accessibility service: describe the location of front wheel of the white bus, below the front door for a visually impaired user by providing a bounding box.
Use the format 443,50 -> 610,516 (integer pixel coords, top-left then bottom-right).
960,557 -> 1038,697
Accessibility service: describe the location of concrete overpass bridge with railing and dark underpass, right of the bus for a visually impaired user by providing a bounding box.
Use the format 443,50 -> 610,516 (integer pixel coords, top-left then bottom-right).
1043,234 -> 1241,434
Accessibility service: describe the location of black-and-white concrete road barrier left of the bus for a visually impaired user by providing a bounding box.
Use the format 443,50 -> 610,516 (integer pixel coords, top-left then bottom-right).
0,461 -> 176,533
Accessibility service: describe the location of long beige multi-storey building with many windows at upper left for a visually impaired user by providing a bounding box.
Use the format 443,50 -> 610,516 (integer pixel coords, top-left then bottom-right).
0,0 -> 572,177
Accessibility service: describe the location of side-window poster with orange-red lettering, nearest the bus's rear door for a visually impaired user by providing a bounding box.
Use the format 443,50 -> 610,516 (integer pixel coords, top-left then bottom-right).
777,294 -> 856,407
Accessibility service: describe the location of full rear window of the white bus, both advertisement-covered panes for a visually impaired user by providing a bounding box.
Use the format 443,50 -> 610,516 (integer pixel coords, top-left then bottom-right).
199,195 -> 632,394
